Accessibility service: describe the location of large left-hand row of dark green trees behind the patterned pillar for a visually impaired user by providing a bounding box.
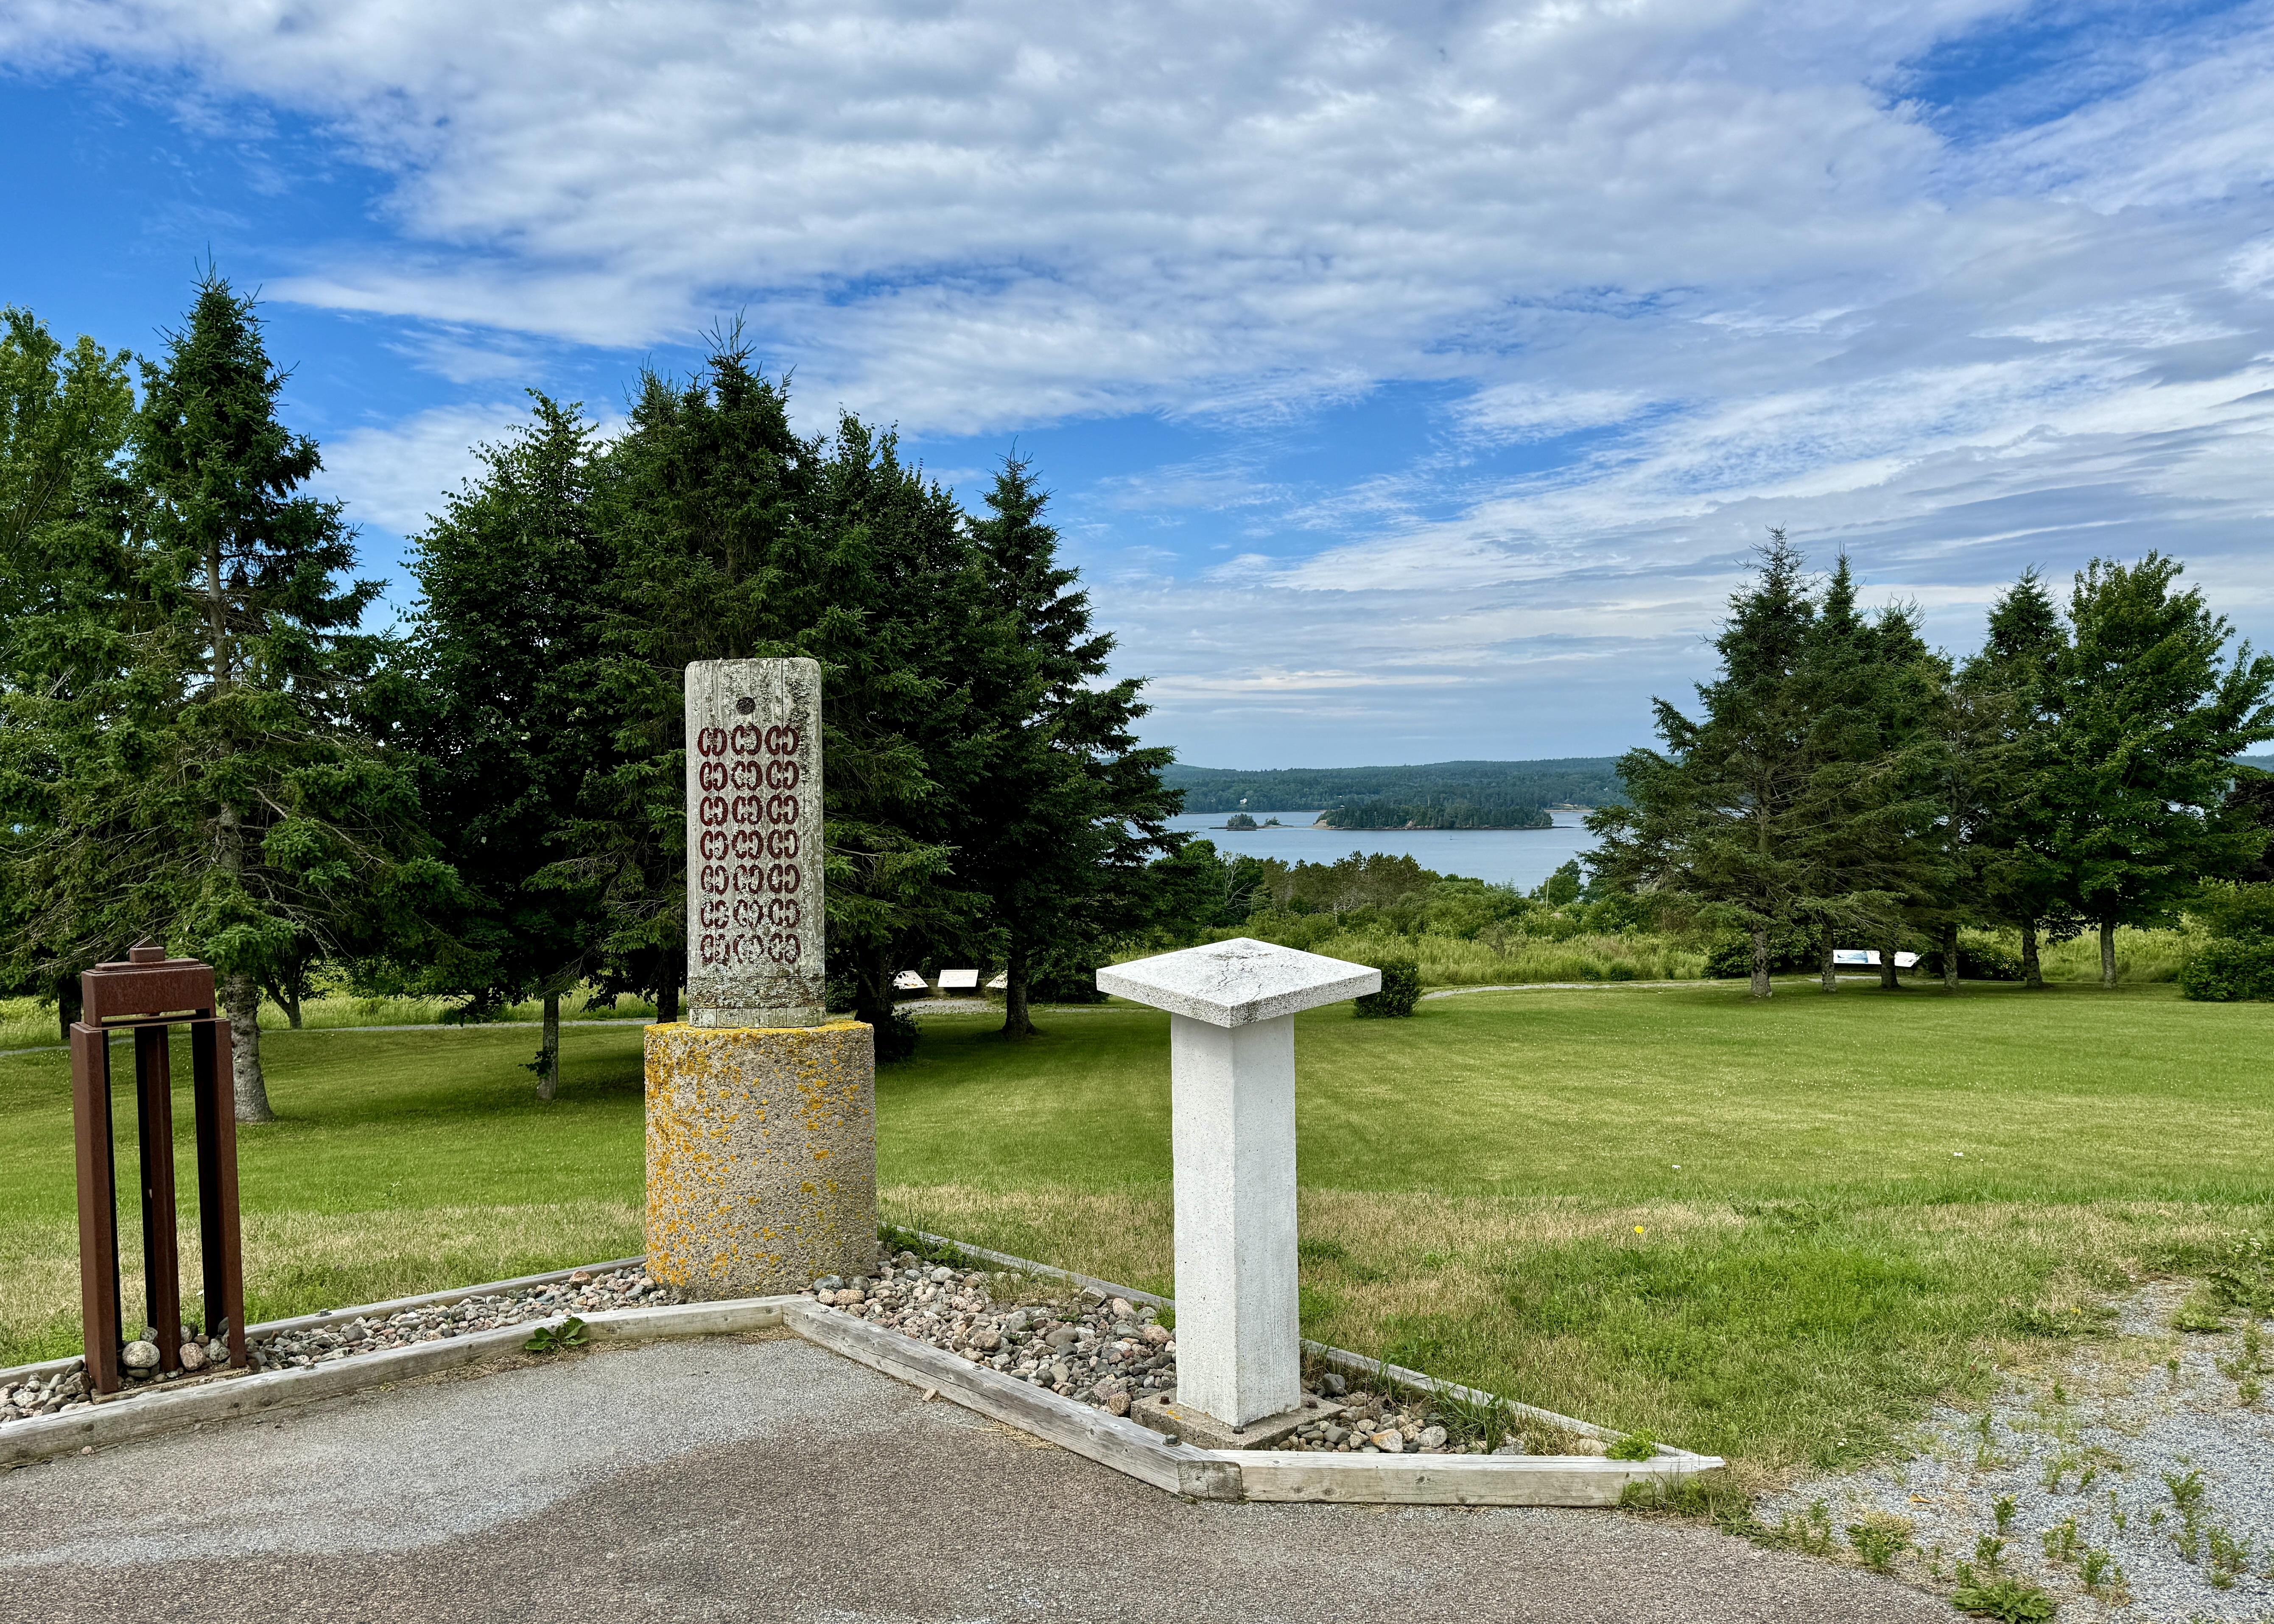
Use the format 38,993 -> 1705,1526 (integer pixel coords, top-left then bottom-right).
0,273 -> 1178,1119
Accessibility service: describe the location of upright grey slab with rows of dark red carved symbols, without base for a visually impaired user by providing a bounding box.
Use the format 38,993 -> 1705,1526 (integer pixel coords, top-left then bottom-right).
687,660 -> 825,1026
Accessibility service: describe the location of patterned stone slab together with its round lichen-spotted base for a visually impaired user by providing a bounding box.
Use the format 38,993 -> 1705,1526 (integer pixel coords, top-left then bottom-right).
646,660 -> 875,1297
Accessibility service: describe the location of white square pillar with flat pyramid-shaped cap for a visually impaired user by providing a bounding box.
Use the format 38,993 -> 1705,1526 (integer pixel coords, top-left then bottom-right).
1098,937 -> 1382,1449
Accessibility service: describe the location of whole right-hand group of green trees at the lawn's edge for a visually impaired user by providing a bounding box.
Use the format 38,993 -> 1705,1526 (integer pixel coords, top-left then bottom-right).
1589,530 -> 2274,998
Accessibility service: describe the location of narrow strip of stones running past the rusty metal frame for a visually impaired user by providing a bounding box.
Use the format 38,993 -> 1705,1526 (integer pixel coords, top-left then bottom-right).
0,1269 -> 685,1426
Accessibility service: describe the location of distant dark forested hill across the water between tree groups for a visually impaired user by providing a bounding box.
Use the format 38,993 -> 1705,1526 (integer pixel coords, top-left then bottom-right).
1162,755 -> 1626,812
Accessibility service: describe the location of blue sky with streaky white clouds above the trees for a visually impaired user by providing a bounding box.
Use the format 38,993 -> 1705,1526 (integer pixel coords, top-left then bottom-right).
0,0 -> 2274,766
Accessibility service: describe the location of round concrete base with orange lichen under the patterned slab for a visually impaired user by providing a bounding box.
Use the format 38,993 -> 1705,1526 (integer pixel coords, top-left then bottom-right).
646,1021 -> 875,1299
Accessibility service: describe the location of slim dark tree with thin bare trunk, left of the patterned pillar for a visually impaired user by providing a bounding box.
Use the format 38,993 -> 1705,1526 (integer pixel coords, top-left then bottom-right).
391,394 -> 618,1099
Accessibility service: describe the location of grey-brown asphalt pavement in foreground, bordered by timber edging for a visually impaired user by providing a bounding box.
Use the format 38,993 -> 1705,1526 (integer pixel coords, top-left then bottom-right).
0,1337 -> 1951,1624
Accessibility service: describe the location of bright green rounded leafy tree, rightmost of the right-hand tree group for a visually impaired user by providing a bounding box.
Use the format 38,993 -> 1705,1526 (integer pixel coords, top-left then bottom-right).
2045,553 -> 2274,985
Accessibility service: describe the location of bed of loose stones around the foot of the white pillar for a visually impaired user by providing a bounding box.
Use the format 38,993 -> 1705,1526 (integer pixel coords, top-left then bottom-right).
812,1251 -> 1603,1456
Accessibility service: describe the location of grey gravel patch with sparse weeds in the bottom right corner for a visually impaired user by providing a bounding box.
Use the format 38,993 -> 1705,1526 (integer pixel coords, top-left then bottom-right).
1760,1280 -> 2274,1624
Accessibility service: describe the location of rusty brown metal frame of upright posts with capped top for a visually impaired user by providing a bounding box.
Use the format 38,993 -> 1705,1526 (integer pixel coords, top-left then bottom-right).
70,946 -> 246,1392
